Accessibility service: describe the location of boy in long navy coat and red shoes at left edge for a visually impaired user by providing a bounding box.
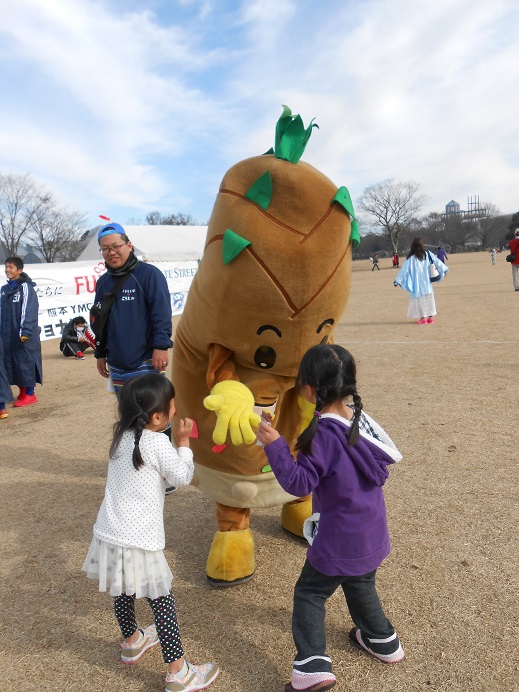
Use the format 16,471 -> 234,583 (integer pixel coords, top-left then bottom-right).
0,257 -> 43,406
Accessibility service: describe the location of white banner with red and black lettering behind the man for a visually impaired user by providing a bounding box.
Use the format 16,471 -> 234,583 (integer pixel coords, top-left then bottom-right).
24,260 -> 198,341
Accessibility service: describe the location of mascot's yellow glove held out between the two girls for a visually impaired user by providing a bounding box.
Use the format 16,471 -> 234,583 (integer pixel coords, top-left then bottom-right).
204,380 -> 261,445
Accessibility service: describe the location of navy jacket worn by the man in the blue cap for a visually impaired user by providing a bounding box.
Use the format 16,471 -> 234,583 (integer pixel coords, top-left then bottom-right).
95,262 -> 173,370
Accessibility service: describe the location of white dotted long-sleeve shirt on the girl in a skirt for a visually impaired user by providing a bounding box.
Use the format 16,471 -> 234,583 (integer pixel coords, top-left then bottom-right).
94,430 -> 194,550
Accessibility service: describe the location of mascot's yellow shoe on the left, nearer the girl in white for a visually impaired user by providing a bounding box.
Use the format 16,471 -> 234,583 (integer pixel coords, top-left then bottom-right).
206,529 -> 256,586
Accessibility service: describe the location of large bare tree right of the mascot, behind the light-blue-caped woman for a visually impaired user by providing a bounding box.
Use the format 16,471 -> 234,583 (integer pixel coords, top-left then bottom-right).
358,179 -> 427,252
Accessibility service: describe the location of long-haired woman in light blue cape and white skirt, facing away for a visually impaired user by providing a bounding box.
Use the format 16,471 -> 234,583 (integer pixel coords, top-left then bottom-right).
393,238 -> 449,324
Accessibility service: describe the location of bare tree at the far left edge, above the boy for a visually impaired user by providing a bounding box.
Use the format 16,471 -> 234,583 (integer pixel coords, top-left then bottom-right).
0,174 -> 43,257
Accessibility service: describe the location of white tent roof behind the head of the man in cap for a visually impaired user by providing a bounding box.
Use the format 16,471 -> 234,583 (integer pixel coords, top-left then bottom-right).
78,226 -> 207,262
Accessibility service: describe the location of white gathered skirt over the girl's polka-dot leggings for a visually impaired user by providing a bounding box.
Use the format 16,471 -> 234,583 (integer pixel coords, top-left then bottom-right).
83,536 -> 173,600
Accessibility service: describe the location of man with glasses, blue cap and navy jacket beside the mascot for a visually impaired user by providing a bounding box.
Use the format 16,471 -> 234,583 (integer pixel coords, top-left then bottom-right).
94,223 -> 173,396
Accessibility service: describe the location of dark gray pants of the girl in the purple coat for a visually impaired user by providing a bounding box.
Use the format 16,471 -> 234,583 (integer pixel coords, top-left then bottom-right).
292,560 -> 395,673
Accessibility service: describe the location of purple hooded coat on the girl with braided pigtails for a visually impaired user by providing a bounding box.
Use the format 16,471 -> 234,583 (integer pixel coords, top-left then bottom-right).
265,414 -> 401,576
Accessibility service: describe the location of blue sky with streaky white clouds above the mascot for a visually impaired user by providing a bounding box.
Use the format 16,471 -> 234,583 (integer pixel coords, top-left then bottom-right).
0,0 -> 519,225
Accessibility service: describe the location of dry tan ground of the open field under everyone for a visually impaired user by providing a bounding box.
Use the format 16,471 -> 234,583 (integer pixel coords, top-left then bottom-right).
0,253 -> 519,692
